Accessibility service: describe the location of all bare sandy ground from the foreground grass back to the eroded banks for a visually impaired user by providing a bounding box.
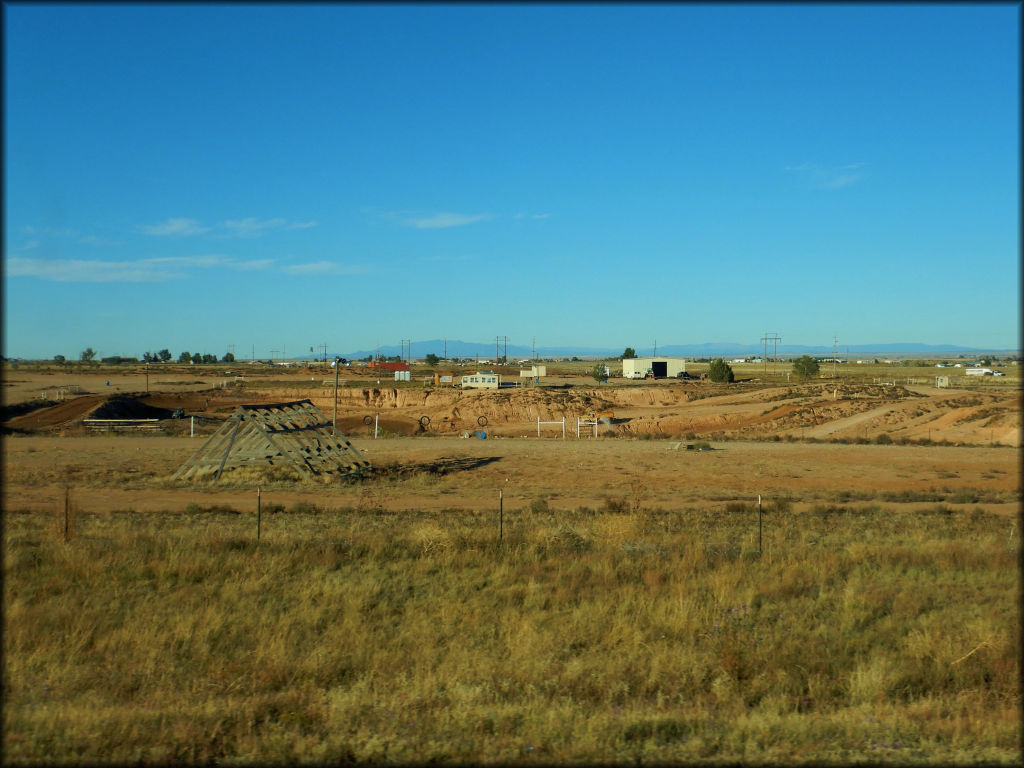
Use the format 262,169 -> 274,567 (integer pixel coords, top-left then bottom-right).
3,372 -> 1021,520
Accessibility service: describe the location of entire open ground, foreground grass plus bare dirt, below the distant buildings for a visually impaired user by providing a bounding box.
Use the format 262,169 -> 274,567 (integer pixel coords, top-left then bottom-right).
2,370 -> 1022,764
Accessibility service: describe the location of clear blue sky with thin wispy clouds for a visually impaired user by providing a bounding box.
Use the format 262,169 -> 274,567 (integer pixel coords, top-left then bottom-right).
3,4 -> 1020,357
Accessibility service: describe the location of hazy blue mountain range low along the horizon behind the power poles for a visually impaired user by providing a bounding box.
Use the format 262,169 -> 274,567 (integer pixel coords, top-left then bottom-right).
341,339 -> 1019,360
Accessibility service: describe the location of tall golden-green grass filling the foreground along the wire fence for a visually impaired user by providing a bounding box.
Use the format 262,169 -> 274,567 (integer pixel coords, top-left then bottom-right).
4,503 -> 1021,764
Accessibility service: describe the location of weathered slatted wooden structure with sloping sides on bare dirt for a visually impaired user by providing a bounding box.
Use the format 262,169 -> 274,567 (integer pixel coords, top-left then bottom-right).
171,400 -> 370,482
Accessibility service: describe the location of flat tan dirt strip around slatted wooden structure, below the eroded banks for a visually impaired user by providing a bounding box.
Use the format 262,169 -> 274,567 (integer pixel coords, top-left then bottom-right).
3,436 -> 1020,514
